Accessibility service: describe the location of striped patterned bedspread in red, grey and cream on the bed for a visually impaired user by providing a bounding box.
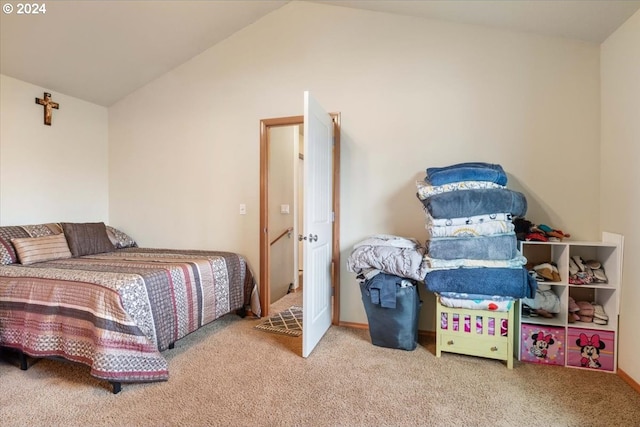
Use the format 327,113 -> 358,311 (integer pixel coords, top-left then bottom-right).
0,248 -> 260,382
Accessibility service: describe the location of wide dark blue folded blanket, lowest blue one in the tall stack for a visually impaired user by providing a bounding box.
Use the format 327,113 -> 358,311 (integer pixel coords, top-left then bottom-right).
424,268 -> 538,298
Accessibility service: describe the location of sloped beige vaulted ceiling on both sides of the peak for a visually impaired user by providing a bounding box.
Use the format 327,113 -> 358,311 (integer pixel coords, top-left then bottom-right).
0,0 -> 640,106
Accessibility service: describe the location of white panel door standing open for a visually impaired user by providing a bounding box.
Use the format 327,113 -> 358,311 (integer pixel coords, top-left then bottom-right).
302,92 -> 333,357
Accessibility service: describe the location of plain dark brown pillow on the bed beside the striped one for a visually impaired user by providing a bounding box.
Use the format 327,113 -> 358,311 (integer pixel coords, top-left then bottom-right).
60,222 -> 115,257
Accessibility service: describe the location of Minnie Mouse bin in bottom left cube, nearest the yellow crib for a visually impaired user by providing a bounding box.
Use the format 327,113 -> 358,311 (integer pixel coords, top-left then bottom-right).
520,323 -> 566,365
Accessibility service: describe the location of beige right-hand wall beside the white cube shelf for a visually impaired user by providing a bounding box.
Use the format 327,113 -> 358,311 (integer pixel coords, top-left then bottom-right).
600,12 -> 640,383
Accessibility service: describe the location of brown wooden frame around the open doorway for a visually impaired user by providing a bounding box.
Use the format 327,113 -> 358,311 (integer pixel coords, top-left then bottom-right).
259,113 -> 340,325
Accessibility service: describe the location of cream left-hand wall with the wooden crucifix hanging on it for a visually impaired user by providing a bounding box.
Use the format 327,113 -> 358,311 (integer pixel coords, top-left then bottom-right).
0,75 -> 109,225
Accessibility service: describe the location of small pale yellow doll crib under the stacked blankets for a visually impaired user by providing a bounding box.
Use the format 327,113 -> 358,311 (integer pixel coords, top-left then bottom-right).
436,297 -> 517,369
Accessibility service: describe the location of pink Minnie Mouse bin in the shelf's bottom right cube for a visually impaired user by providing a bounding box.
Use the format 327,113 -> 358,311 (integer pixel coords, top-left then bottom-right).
567,328 -> 616,372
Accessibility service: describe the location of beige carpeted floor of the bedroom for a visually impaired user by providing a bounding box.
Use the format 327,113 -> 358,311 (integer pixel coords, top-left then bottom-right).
0,294 -> 640,427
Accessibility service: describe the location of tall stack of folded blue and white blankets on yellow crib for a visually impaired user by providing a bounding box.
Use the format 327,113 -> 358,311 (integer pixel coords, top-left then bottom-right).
417,162 -> 537,306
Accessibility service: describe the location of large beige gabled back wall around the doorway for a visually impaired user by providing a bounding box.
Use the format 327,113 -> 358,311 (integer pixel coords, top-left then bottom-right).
109,2 -> 600,329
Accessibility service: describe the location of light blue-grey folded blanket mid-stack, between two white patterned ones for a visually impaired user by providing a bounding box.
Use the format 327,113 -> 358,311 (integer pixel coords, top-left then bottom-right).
428,232 -> 518,260
